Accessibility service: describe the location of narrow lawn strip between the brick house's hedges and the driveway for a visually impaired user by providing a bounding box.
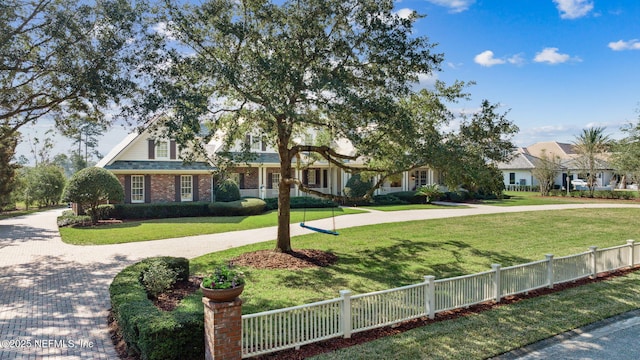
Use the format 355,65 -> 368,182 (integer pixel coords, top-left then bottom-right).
60,208 -> 364,245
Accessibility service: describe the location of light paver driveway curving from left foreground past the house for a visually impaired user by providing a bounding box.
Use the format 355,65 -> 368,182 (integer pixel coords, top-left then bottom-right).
0,204 -> 640,360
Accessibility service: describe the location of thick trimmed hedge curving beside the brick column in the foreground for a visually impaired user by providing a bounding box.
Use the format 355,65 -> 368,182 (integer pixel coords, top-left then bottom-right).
109,257 -> 205,360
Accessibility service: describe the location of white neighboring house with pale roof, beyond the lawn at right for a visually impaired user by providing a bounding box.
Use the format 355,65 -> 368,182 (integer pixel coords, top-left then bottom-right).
498,141 -> 615,189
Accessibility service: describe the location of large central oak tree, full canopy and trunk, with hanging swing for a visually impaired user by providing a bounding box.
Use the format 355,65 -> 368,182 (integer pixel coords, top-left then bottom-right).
131,0 -> 515,251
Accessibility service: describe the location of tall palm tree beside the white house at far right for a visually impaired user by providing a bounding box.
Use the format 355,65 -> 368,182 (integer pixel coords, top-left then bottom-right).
573,127 -> 613,196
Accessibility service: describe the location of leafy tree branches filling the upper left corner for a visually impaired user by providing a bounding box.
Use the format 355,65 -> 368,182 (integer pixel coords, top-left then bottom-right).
0,0 -> 139,144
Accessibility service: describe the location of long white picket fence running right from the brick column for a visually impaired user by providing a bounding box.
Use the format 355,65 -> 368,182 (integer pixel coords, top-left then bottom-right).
242,240 -> 640,358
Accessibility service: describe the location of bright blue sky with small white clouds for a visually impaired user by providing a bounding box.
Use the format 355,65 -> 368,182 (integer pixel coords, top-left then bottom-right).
13,0 -> 640,162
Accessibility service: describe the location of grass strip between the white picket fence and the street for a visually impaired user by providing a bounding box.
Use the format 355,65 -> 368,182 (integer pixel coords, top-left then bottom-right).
314,271 -> 640,360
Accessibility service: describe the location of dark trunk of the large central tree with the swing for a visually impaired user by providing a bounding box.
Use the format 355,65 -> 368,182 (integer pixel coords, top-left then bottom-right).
275,142 -> 292,252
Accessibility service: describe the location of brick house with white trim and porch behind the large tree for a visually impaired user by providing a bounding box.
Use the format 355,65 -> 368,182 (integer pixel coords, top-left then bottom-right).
96,118 -> 440,203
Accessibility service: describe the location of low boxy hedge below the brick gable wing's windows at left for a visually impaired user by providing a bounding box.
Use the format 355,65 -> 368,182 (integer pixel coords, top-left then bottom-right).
111,202 -> 209,220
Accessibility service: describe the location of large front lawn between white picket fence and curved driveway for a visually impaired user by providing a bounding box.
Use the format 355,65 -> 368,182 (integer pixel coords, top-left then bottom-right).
191,209 -> 640,313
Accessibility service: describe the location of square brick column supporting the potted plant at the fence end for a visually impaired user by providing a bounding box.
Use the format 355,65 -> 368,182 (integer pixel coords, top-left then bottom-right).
202,297 -> 242,360
